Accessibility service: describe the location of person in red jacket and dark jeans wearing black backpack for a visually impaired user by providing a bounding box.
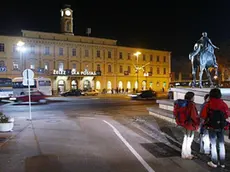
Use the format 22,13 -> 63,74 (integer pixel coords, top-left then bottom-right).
201,88 -> 229,168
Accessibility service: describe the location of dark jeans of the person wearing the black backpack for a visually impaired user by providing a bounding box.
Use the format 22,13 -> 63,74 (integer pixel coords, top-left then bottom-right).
209,130 -> 225,165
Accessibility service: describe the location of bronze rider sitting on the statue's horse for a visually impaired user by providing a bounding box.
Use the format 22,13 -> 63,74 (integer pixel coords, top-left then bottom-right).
198,32 -> 219,68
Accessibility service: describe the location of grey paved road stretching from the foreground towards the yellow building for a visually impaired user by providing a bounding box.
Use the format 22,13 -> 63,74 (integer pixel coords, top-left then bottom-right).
0,97 -> 221,172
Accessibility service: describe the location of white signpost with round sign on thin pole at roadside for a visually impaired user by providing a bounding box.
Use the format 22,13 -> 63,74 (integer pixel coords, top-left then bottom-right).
22,69 -> 34,120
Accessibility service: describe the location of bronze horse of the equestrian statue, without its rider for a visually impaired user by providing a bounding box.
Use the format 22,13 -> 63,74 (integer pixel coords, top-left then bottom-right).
189,43 -> 218,88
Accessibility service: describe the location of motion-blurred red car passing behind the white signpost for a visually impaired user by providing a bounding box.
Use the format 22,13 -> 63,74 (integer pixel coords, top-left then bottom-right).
16,91 -> 47,103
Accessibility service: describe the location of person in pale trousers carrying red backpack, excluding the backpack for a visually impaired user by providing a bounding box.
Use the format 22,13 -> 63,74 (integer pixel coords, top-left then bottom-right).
181,92 -> 200,159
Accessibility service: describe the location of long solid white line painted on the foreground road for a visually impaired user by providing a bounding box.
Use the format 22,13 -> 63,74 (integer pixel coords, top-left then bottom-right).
103,120 -> 155,172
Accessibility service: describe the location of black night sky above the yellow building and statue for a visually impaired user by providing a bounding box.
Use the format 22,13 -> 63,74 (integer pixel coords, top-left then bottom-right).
0,0 -> 230,59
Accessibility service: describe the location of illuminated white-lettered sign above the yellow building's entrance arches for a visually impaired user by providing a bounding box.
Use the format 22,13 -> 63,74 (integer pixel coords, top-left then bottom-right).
53,69 -> 101,76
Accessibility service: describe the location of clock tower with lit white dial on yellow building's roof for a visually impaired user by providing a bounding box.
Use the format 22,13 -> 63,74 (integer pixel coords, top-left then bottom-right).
61,5 -> 74,35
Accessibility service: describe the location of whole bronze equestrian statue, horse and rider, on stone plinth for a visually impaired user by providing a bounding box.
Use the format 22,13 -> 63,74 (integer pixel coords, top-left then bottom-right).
189,32 -> 219,88
